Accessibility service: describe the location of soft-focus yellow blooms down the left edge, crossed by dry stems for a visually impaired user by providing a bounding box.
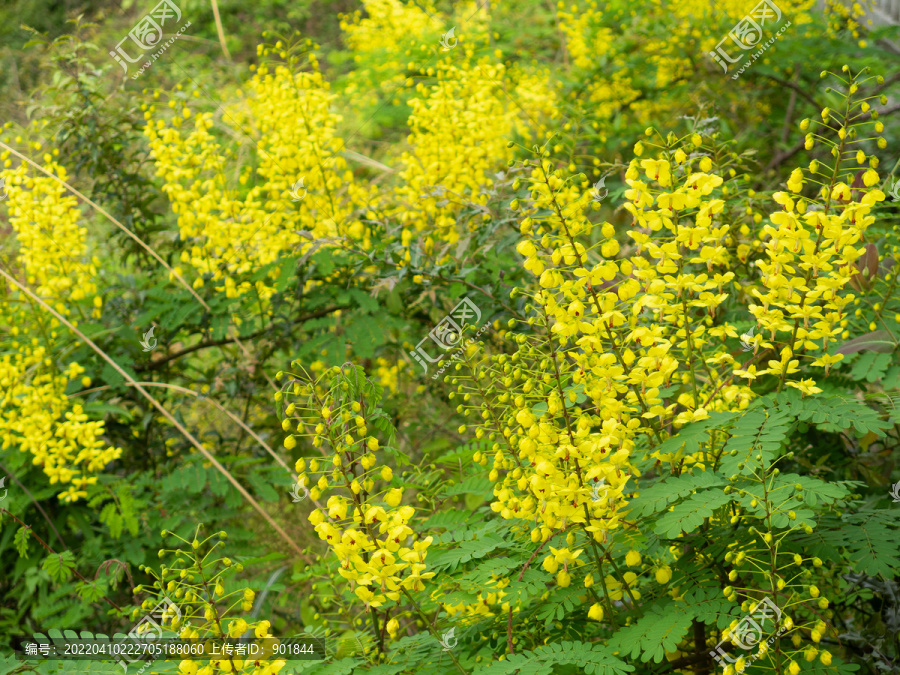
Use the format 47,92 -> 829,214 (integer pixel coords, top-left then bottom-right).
0,154 -> 122,502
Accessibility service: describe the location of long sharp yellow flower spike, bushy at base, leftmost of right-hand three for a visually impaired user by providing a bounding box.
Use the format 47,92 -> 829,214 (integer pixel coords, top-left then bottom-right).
453,161 -> 655,556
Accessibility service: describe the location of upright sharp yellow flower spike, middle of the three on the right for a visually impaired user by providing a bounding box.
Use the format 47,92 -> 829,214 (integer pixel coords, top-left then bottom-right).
623,145 -> 753,428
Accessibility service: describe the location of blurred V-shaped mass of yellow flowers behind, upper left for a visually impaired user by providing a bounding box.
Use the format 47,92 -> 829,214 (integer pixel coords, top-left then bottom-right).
145,55 -> 371,300
